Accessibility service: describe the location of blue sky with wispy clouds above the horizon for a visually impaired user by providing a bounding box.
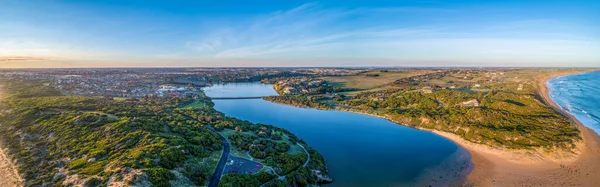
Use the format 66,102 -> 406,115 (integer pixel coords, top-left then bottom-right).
0,0 -> 600,68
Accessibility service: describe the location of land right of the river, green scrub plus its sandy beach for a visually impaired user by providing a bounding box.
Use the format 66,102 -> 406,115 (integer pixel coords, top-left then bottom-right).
265,69 -> 600,186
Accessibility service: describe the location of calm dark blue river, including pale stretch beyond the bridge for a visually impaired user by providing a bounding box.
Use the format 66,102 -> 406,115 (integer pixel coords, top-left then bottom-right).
204,83 -> 472,187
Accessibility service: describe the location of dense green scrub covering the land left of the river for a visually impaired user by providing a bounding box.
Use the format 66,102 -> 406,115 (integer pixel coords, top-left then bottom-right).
0,80 -> 326,186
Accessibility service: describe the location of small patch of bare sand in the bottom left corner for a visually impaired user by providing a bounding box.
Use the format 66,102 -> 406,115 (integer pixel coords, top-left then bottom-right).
0,85 -> 23,187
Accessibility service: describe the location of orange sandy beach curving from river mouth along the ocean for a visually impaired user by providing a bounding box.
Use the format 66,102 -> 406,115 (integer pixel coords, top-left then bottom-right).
433,71 -> 600,187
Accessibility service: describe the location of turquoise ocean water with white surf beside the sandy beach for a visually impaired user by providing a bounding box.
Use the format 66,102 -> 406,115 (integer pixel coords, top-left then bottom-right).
546,71 -> 600,134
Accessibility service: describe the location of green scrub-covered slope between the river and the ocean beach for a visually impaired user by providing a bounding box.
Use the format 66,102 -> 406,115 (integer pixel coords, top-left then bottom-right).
266,71 -> 581,152
